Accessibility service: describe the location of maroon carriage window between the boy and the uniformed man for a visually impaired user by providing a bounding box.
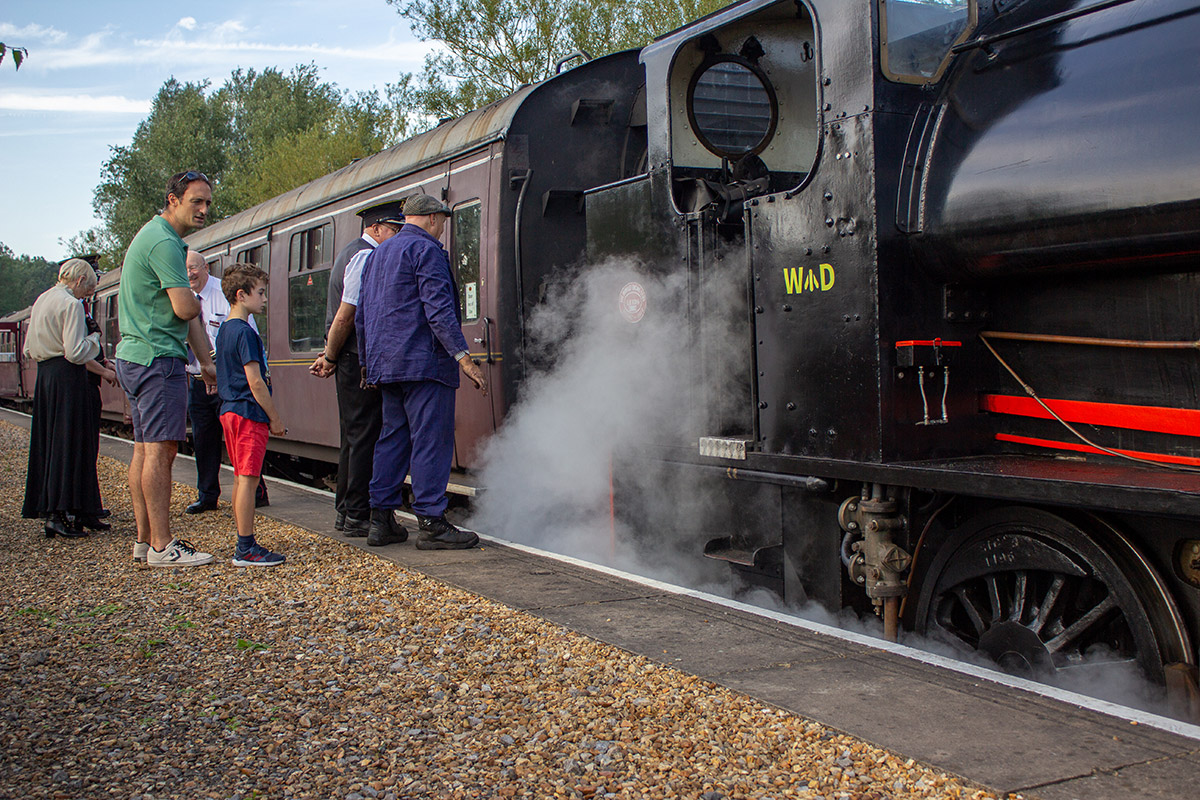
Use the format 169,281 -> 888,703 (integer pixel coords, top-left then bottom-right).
288,222 -> 334,353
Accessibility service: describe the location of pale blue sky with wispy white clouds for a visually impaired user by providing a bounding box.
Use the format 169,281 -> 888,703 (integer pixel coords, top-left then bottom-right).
0,0 -> 430,260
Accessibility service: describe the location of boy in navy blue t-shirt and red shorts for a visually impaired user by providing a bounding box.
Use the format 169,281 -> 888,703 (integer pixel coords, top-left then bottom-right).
215,264 -> 287,566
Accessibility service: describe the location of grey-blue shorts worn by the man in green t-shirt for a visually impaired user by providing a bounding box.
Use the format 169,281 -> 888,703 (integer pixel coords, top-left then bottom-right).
116,356 -> 187,441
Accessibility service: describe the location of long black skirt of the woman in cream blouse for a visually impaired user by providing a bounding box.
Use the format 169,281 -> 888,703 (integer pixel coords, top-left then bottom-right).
22,357 -> 101,517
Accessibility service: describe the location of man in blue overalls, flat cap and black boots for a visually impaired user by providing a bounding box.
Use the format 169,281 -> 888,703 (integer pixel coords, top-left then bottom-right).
355,194 -> 487,551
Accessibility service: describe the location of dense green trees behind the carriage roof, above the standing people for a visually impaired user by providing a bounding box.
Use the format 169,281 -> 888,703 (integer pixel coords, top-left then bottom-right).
84,64 -> 406,260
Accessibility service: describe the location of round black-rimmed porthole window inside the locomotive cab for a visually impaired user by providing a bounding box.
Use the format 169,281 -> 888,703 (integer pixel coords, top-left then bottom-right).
688,56 -> 779,158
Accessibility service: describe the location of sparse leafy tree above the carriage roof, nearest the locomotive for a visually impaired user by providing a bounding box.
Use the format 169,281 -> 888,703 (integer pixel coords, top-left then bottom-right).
388,0 -> 730,119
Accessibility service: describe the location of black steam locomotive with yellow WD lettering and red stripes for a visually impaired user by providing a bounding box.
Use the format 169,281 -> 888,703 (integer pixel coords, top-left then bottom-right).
586,0 -> 1200,714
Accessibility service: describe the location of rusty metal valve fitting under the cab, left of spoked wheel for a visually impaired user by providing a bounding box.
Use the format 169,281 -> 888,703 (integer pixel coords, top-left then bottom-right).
838,483 -> 912,642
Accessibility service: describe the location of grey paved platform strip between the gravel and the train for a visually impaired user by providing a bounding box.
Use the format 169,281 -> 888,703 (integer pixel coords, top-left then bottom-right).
0,411 -> 1200,800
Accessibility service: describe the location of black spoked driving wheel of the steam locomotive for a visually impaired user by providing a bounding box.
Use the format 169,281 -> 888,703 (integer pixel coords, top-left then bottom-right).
916,507 -> 1190,688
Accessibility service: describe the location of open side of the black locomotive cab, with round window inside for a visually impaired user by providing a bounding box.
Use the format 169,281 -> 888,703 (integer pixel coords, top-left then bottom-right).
670,0 -> 818,215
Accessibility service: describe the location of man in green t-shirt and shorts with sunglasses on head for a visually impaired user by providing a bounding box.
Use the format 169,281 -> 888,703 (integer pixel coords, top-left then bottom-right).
116,172 -> 223,566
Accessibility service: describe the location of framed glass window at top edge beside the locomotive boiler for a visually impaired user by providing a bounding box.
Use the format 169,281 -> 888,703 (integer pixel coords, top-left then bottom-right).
880,0 -> 976,83
